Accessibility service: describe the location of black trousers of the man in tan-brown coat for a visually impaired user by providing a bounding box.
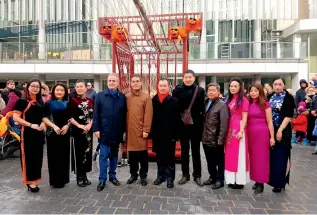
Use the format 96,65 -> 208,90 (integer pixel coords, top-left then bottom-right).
129,150 -> 149,178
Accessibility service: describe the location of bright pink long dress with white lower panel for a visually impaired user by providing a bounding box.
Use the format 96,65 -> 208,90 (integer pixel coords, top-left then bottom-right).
225,95 -> 250,185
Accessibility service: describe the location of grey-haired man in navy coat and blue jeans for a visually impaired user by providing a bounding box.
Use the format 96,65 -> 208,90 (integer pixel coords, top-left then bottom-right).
93,73 -> 127,192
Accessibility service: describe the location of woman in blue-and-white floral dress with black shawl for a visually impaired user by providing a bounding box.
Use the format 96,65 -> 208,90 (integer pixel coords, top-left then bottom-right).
268,77 -> 296,193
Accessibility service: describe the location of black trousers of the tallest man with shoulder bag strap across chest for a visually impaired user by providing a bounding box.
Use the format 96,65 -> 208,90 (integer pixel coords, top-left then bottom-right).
180,126 -> 201,178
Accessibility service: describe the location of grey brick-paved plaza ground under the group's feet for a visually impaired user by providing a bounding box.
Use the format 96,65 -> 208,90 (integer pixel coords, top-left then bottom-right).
0,146 -> 317,214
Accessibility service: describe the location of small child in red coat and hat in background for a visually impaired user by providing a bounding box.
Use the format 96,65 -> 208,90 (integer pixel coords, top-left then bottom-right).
292,102 -> 308,146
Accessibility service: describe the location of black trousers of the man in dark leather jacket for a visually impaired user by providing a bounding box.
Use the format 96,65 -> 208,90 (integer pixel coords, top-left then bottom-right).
203,144 -> 225,182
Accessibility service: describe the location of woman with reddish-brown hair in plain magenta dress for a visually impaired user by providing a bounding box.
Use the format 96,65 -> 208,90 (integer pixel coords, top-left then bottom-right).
247,84 -> 275,194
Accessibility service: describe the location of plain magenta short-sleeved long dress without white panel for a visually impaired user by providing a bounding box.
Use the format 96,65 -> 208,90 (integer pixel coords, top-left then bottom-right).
247,102 -> 270,184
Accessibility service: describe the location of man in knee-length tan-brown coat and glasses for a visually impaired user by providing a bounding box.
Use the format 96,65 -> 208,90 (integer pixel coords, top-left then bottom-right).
126,75 -> 153,186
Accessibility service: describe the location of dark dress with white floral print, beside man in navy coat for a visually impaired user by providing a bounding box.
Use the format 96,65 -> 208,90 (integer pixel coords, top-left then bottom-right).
68,97 -> 94,177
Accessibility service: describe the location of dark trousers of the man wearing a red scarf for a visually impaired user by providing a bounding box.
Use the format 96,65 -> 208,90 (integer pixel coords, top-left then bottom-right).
156,141 -> 176,183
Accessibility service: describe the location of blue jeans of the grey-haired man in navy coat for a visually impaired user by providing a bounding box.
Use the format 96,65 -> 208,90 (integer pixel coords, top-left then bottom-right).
99,144 -> 118,183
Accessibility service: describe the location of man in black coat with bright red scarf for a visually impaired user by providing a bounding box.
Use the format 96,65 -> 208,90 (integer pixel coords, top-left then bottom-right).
150,79 -> 181,188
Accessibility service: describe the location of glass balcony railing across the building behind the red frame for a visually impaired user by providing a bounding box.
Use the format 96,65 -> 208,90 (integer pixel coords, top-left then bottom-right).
0,42 -> 308,63
